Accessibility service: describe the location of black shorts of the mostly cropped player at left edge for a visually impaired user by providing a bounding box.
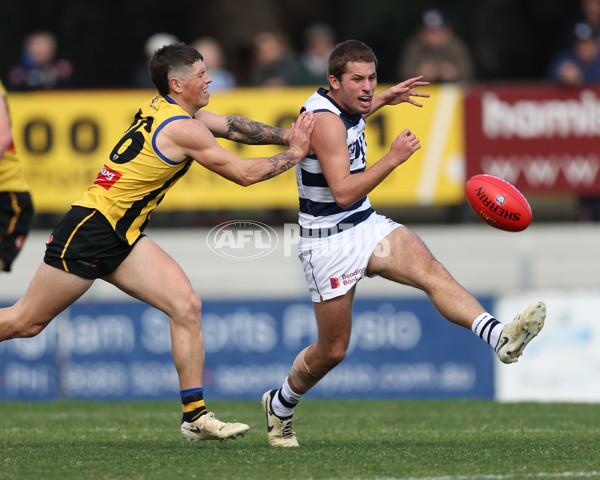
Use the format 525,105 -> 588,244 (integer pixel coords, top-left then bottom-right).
0,192 -> 34,272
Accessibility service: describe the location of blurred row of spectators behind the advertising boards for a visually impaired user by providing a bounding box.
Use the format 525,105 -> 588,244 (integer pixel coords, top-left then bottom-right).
5,0 -> 600,91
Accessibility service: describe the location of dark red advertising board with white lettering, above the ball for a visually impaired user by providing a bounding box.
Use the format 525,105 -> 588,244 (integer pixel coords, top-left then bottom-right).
464,84 -> 600,197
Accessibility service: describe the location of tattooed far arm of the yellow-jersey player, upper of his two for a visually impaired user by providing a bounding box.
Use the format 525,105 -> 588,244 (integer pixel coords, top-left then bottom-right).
195,110 -> 290,145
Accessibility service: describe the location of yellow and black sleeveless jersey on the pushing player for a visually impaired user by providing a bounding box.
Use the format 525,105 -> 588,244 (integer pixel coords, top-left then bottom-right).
73,96 -> 193,245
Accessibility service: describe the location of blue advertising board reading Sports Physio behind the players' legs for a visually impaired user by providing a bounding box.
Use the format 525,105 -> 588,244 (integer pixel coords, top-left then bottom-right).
0,298 -> 494,400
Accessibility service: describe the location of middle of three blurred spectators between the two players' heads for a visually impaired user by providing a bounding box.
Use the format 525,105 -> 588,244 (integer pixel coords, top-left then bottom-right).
250,30 -> 297,87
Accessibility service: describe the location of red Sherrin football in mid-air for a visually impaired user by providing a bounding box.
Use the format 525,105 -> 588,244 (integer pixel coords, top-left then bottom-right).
465,174 -> 531,232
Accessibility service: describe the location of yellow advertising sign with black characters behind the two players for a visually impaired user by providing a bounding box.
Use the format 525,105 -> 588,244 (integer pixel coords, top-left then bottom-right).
9,86 -> 464,213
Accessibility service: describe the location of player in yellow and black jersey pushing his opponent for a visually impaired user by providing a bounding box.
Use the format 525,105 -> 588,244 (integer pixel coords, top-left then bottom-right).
0,44 -> 314,441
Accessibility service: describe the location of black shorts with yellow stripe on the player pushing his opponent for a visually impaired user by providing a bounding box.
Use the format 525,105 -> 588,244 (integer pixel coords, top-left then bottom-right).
44,207 -> 138,279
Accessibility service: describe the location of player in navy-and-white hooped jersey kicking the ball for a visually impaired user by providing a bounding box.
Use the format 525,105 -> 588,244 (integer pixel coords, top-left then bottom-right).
262,40 -> 546,447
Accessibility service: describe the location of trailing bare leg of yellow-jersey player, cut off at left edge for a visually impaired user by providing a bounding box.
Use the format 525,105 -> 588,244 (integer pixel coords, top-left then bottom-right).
0,263 -> 93,341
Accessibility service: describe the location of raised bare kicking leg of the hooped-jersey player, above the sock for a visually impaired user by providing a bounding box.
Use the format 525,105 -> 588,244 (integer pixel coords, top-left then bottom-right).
367,226 -> 485,329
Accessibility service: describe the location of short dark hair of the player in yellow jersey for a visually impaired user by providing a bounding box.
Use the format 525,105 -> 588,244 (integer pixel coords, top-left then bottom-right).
148,42 -> 204,96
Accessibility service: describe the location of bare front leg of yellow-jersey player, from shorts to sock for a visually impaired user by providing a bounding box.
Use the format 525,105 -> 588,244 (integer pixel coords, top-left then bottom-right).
103,237 -> 204,390
